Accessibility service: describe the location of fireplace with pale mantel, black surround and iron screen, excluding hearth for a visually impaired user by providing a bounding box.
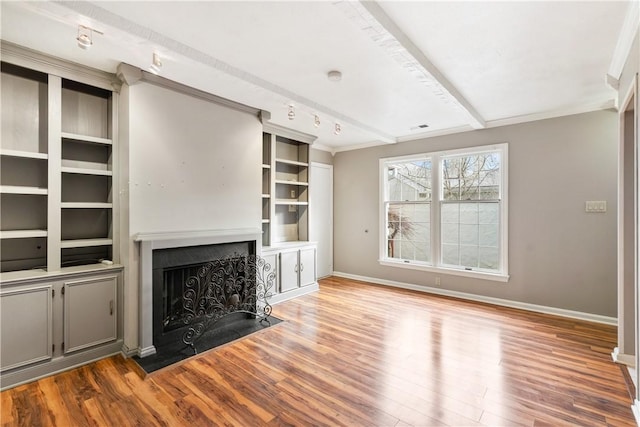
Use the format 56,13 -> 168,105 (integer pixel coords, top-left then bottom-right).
135,229 -> 270,357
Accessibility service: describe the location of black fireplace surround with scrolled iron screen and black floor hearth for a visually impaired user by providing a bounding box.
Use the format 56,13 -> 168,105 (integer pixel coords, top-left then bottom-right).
134,241 -> 280,372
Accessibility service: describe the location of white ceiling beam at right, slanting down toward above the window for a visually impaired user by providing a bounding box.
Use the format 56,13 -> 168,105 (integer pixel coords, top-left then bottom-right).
356,0 -> 486,129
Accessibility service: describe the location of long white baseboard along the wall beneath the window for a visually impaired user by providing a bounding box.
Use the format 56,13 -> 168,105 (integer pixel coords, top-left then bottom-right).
333,271 -> 618,326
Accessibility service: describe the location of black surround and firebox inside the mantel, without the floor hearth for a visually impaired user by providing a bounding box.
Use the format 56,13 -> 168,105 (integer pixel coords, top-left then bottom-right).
153,241 -> 257,351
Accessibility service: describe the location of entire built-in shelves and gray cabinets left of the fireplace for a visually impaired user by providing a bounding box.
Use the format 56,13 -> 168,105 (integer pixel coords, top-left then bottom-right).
0,42 -> 123,388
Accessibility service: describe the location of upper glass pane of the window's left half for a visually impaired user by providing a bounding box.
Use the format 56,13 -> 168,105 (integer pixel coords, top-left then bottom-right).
387,159 -> 431,201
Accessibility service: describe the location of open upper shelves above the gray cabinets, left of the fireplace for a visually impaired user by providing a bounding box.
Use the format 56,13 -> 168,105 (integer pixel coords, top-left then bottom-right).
0,58 -> 115,273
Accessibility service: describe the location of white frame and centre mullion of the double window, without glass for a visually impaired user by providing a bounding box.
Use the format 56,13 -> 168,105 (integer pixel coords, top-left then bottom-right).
378,143 -> 509,282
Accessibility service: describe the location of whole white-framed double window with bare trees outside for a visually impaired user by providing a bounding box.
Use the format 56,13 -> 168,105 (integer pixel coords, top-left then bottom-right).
380,144 -> 508,281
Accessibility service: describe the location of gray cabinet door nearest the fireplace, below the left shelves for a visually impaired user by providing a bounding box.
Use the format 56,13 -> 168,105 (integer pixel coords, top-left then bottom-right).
64,276 -> 118,354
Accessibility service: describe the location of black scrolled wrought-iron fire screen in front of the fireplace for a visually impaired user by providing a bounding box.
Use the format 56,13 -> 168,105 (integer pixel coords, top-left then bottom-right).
176,254 -> 276,353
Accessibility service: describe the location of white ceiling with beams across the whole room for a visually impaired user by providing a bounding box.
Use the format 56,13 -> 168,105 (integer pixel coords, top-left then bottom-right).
1,1 -> 630,151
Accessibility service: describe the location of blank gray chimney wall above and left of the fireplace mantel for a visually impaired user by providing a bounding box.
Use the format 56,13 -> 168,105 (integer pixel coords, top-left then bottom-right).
120,83 -> 262,349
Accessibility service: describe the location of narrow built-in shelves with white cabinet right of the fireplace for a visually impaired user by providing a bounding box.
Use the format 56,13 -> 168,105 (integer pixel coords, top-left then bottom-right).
262,125 -> 318,301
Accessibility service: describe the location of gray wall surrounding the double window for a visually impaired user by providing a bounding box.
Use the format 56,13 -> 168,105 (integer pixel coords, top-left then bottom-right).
333,111 -> 618,316
